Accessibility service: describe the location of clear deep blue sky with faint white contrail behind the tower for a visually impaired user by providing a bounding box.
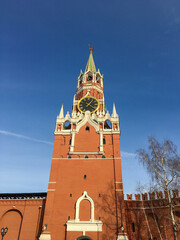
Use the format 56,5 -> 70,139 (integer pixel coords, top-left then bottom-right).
0,0 -> 180,193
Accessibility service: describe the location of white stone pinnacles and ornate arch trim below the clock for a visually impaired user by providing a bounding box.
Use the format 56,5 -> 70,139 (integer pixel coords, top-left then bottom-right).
54,96 -> 120,154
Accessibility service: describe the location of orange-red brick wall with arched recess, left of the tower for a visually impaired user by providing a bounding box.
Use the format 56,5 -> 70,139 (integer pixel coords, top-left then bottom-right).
0,199 -> 45,240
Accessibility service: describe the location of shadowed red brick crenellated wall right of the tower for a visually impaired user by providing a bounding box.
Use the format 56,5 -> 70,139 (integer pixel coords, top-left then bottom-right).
125,190 -> 180,240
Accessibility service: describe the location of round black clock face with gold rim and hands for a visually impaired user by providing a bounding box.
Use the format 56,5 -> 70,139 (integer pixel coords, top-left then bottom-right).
78,97 -> 99,113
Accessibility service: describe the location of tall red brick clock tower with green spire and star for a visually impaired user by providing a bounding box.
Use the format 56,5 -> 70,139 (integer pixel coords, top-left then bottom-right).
40,48 -> 128,240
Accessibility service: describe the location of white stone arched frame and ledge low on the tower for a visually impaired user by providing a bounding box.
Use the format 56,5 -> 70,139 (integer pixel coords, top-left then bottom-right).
66,191 -> 103,234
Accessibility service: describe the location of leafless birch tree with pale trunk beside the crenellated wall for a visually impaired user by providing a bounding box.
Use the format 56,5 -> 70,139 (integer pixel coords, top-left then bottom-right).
137,137 -> 180,240
